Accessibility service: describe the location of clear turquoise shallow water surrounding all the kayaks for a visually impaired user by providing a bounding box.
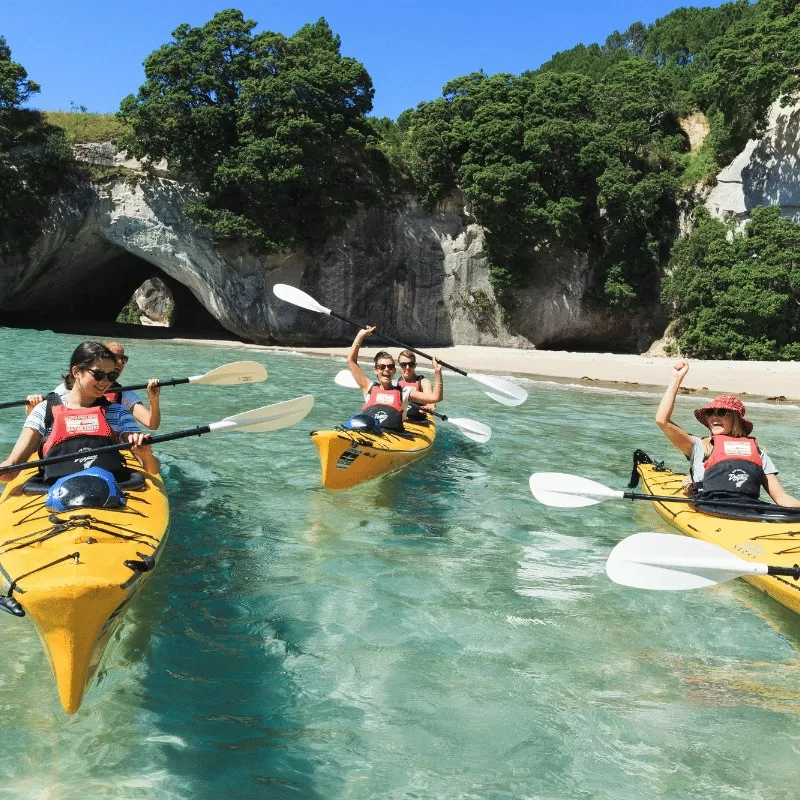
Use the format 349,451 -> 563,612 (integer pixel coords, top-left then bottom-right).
0,329 -> 800,800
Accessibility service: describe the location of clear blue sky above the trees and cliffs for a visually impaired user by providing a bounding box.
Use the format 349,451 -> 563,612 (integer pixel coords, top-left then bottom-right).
0,0 -> 723,118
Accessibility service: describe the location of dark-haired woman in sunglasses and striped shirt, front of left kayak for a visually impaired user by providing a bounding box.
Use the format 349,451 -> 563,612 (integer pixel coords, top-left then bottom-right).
0,342 -> 160,483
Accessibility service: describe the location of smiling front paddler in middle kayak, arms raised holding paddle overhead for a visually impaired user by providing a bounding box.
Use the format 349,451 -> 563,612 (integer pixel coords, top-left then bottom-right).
347,326 -> 444,431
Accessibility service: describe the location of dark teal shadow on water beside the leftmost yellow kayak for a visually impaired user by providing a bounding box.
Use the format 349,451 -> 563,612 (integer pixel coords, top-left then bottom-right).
126,465 -> 330,799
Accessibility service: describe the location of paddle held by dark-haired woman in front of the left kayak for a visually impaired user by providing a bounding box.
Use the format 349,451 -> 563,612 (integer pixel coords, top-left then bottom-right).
0,394 -> 314,473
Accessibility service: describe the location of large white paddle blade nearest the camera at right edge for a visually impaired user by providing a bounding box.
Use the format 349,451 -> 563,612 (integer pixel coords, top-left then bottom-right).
606,532 -> 800,590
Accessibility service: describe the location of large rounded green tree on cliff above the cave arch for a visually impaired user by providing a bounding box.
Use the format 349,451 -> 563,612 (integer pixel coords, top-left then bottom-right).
120,9 -> 380,248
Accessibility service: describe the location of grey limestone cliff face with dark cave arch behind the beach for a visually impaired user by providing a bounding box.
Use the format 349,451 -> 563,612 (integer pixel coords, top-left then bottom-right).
0,145 -> 665,350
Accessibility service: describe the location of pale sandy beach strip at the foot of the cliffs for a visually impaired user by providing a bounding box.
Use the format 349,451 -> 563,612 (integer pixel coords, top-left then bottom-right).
170,340 -> 800,403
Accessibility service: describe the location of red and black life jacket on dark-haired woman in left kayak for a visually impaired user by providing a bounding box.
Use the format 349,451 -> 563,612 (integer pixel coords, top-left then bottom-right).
41,394 -> 123,481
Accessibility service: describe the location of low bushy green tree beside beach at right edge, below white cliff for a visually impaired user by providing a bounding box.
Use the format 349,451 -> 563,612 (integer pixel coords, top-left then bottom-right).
663,206 -> 800,359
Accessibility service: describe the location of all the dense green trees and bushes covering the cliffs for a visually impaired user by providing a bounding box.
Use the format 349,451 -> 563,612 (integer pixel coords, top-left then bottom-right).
0,0 -> 800,358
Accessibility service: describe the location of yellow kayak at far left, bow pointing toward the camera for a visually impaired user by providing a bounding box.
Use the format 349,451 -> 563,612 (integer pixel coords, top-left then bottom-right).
0,455 -> 169,714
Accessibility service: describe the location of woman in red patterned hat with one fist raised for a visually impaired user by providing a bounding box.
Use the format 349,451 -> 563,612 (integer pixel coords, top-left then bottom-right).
656,361 -> 800,508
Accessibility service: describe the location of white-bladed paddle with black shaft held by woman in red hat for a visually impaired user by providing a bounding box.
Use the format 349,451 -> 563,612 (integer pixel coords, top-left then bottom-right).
530,472 -> 789,511
